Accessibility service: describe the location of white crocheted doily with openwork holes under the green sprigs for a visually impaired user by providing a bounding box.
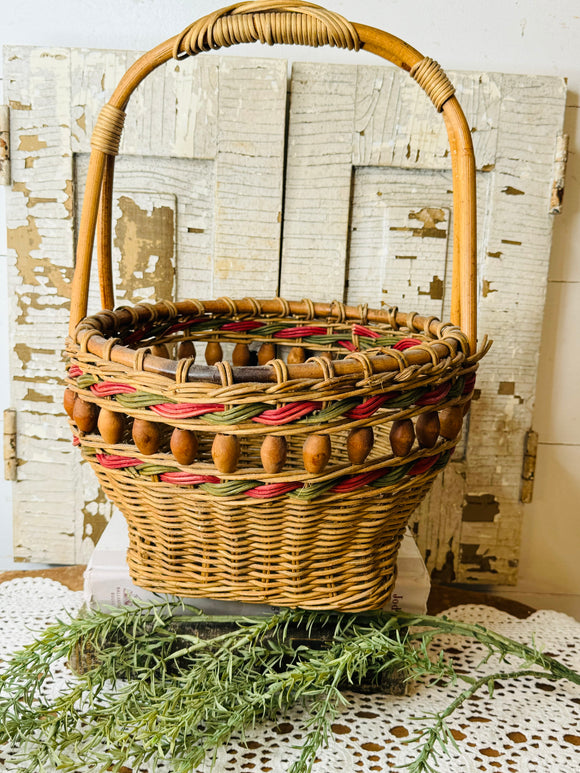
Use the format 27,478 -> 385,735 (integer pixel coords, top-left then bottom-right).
0,579 -> 580,773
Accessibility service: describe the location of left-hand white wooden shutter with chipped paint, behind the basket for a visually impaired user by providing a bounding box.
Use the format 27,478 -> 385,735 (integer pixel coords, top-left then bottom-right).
4,47 -> 287,563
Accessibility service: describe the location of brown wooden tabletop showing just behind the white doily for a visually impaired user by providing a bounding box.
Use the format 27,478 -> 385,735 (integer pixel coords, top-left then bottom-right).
0,565 -> 535,620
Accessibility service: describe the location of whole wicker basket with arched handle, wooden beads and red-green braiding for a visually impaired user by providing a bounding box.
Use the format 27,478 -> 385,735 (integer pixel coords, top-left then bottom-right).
65,0 -> 487,611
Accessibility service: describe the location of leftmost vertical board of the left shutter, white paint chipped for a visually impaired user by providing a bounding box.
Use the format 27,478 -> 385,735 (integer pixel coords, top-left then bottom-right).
4,47 -> 78,563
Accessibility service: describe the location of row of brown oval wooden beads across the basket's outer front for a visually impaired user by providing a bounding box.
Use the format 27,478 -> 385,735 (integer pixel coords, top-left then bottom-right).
65,390 -> 463,474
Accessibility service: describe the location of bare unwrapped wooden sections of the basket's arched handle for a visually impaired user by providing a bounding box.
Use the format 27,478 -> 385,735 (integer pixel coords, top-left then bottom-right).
69,1 -> 477,353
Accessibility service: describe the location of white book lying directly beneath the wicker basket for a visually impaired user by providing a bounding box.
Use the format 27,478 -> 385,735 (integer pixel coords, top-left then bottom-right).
84,510 -> 431,616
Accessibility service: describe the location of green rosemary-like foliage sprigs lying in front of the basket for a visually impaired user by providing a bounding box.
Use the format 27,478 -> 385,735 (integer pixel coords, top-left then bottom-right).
0,602 -> 580,773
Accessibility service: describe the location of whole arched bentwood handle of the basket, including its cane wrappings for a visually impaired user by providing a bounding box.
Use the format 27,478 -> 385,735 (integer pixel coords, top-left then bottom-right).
69,0 -> 477,352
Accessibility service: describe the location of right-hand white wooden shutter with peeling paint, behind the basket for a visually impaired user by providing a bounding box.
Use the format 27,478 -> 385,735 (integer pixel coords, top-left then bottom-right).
281,64 -> 566,584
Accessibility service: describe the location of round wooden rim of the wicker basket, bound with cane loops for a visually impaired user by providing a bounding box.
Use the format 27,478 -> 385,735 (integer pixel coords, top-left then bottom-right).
69,297 -> 491,384
